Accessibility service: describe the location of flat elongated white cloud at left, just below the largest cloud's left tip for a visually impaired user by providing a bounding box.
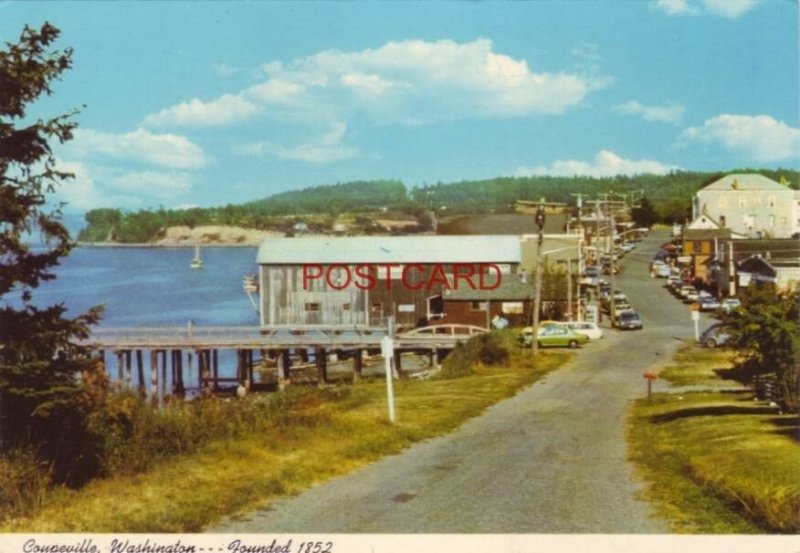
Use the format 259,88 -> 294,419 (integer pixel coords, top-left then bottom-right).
65,129 -> 208,169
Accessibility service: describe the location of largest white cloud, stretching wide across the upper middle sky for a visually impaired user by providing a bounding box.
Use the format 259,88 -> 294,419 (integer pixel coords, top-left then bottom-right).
145,39 -> 609,130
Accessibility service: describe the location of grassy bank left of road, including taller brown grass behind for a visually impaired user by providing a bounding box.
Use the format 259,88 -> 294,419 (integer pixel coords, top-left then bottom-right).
0,337 -> 569,532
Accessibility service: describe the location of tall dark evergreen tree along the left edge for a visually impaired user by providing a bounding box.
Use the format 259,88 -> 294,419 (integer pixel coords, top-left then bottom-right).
0,23 -> 100,481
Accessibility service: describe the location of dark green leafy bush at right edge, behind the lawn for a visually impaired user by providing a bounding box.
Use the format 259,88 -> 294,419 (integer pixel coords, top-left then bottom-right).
723,286 -> 800,410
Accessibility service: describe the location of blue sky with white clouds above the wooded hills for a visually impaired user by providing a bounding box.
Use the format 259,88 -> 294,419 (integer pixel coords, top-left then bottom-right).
0,0 -> 800,212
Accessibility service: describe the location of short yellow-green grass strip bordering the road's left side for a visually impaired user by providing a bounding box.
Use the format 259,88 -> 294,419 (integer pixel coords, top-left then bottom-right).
0,340 -> 569,532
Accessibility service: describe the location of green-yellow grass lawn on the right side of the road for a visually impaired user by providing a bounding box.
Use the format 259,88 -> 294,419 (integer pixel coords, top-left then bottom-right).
628,348 -> 800,534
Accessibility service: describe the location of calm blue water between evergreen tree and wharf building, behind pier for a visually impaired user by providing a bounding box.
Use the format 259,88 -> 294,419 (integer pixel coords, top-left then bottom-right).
34,247 -> 258,326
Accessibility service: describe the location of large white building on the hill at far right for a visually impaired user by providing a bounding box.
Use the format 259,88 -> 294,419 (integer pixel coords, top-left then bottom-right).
689,174 -> 800,238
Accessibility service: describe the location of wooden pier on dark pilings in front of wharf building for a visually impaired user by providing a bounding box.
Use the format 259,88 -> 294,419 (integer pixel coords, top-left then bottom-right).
83,325 -> 486,400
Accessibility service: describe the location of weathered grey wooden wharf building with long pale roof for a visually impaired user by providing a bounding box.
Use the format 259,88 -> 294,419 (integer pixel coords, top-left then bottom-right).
257,235 -> 521,328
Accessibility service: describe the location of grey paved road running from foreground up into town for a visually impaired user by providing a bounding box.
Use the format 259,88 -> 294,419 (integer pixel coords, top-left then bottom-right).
208,234 -> 712,534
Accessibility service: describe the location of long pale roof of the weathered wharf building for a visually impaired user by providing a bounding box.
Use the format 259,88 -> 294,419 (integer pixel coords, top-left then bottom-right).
256,235 -> 521,265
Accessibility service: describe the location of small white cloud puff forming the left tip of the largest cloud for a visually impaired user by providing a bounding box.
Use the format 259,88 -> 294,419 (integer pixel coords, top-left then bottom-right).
143,94 -> 261,127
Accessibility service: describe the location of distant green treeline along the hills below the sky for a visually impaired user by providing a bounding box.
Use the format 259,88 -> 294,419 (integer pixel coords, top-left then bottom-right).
78,169 -> 800,243
